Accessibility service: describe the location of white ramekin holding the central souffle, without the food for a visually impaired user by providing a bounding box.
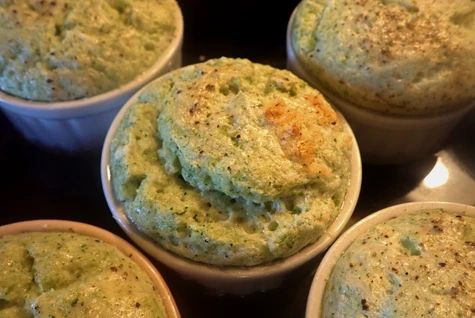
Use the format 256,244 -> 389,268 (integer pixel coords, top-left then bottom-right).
101,71 -> 362,295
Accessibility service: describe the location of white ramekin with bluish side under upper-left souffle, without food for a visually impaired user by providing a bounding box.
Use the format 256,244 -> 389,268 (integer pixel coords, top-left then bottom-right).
0,4 -> 183,152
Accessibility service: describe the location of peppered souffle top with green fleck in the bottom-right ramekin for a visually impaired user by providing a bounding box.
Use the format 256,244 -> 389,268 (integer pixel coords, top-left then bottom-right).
322,209 -> 475,318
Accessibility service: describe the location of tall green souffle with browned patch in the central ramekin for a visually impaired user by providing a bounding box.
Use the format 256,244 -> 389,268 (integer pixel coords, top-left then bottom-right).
111,58 -> 352,266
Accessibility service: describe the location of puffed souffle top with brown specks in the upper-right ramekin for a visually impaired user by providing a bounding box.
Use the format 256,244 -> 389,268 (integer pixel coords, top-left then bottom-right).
291,0 -> 475,115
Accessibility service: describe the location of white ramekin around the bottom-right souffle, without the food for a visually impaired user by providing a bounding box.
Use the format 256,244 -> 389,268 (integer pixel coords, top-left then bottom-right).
305,202 -> 475,318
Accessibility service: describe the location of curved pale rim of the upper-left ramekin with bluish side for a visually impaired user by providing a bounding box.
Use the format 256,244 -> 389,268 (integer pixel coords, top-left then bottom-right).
0,1 -> 184,117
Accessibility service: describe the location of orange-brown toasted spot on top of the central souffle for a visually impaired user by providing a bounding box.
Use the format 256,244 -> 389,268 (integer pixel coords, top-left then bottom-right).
264,101 -> 337,177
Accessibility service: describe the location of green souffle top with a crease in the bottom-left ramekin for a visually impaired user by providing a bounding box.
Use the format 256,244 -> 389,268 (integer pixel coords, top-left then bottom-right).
0,232 -> 165,318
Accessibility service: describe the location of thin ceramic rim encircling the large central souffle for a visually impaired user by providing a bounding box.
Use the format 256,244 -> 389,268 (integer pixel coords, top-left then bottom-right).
101,60 -> 362,282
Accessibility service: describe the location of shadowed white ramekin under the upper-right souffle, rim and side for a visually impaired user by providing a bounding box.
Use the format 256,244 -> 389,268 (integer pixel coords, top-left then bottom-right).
286,9 -> 475,164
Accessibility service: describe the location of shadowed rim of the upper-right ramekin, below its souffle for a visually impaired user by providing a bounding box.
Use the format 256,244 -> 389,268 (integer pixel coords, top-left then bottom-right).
286,3 -> 475,124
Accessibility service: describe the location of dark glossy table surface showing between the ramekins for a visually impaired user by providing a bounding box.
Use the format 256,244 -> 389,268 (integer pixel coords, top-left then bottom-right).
0,0 -> 475,318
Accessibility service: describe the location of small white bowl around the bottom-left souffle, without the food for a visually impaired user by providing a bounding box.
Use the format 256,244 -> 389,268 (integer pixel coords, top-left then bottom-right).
0,220 -> 180,318
